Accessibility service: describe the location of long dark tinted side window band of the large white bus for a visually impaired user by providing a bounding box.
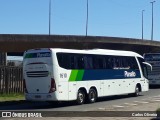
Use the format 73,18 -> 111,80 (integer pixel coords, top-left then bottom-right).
57,53 -> 138,69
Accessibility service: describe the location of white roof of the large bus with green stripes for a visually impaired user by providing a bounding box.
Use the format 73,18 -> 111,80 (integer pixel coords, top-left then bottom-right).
26,48 -> 143,58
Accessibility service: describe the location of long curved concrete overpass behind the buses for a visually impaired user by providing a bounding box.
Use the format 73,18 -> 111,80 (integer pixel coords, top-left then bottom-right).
0,34 -> 160,55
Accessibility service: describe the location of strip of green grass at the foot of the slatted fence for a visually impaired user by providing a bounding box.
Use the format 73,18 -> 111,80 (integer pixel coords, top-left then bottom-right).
0,93 -> 24,102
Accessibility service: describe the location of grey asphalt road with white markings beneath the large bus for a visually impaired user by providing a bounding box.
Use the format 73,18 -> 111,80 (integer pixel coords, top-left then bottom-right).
0,87 -> 160,120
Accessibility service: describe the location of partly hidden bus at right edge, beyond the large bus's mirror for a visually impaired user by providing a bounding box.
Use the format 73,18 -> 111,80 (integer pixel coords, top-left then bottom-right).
144,53 -> 160,85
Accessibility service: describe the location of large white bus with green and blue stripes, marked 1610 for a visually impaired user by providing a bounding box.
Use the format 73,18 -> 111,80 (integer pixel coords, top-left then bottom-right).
23,48 -> 151,104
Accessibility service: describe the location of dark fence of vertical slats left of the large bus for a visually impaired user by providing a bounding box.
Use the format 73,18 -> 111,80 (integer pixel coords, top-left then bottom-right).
0,66 -> 24,94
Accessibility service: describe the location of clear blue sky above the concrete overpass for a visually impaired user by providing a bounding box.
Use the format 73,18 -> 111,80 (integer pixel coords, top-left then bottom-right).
0,0 -> 160,41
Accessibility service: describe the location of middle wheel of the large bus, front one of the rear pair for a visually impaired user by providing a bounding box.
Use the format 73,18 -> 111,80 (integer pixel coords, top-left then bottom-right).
88,88 -> 97,103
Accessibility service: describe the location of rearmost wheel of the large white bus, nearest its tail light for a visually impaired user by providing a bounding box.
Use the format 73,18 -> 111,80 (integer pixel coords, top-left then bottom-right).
77,90 -> 86,105
